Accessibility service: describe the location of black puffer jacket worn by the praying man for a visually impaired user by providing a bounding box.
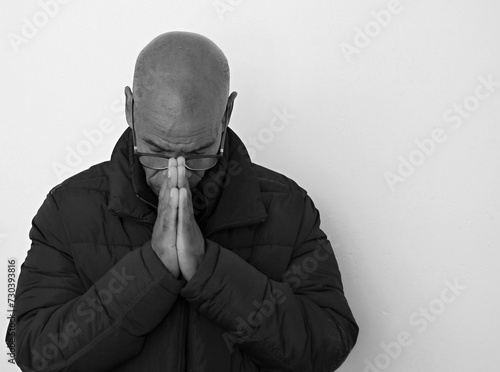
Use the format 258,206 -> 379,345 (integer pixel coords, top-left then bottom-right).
9,129 -> 358,372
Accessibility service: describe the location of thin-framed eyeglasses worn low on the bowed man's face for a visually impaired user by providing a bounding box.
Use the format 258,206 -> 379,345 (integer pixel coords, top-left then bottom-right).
132,97 -> 228,171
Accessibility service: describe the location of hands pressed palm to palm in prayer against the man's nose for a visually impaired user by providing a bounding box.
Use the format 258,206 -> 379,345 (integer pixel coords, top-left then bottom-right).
151,157 -> 205,280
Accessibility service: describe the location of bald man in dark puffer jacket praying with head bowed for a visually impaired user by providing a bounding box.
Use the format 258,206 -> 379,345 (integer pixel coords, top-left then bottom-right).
7,32 -> 358,372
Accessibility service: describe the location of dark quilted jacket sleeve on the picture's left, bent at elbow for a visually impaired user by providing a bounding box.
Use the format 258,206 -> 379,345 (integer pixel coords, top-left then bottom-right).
9,194 -> 185,372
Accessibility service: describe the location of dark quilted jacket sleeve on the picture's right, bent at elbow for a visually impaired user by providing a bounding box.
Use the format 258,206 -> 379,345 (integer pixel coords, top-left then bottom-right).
181,196 -> 358,372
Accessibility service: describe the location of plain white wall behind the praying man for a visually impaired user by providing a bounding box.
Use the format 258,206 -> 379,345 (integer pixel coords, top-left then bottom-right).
0,0 -> 500,372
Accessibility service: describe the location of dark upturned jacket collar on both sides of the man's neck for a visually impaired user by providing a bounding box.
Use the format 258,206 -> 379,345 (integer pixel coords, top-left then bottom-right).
108,128 -> 267,235
